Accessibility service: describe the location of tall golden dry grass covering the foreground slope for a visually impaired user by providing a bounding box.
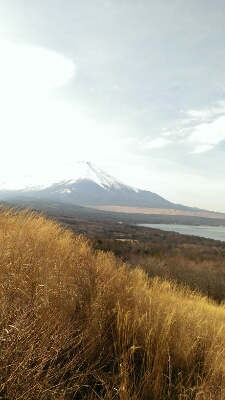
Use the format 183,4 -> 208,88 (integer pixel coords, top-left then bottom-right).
0,208 -> 225,400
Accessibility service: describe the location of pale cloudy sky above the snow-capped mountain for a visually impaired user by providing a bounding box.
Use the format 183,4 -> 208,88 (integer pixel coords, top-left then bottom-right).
0,0 -> 225,212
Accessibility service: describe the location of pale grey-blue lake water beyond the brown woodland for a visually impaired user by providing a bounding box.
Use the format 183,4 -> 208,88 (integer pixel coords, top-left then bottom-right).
138,224 -> 225,242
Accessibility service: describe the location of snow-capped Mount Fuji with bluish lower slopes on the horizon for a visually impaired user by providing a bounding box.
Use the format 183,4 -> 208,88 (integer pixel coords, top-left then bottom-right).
0,161 -> 189,209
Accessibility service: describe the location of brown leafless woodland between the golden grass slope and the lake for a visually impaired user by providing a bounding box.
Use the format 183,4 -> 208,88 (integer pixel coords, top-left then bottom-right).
54,215 -> 225,303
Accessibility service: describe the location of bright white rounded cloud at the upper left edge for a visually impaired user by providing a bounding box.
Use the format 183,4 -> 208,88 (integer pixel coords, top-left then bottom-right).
0,41 -> 75,97
